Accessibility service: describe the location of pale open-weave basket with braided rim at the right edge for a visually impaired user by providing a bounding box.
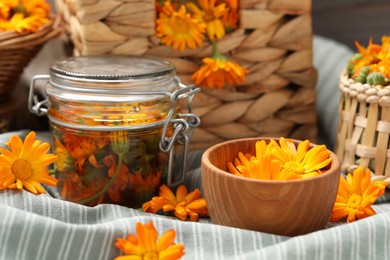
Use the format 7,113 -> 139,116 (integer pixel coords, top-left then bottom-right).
336,71 -> 390,183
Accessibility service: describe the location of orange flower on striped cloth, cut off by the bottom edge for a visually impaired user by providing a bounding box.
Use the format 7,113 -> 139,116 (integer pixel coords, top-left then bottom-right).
115,221 -> 185,260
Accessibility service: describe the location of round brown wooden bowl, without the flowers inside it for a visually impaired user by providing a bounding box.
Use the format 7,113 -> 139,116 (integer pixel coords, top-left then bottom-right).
202,138 -> 341,236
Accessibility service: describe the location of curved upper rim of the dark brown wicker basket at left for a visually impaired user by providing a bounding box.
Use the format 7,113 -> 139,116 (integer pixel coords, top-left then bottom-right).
0,15 -> 61,50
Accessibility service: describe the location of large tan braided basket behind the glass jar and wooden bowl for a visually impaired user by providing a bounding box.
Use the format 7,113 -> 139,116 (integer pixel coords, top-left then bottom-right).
56,0 -> 317,149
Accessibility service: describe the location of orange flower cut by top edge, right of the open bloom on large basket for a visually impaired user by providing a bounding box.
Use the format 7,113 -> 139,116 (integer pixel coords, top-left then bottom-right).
187,0 -> 228,41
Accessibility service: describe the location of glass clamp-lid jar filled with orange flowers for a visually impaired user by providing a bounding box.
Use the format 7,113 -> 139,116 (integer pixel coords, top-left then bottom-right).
29,56 -> 200,208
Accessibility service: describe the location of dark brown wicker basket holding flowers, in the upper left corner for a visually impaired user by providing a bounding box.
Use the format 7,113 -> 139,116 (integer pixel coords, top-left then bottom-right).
0,16 -> 61,100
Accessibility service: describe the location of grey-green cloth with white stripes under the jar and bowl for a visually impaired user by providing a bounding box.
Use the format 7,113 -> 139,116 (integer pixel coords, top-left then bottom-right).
0,37 -> 390,260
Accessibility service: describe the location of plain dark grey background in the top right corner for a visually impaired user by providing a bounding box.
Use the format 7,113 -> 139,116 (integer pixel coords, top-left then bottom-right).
312,0 -> 390,50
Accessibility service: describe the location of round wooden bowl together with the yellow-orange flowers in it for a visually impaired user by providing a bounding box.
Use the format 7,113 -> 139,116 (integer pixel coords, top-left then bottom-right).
202,138 -> 340,236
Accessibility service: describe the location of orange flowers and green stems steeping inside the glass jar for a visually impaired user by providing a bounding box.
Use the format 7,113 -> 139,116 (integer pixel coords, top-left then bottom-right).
52,102 -> 172,208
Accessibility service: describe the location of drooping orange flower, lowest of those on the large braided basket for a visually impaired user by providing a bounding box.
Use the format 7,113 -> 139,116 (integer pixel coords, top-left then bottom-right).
192,55 -> 249,89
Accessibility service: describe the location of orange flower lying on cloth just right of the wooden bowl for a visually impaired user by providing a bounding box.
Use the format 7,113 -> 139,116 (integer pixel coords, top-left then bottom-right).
330,167 -> 387,222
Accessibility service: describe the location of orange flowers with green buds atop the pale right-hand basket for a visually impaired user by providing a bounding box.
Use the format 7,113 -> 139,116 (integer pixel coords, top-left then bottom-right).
347,36 -> 390,86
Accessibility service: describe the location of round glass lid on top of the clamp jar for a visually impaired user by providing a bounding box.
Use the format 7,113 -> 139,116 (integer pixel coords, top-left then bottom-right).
46,55 -> 178,102
